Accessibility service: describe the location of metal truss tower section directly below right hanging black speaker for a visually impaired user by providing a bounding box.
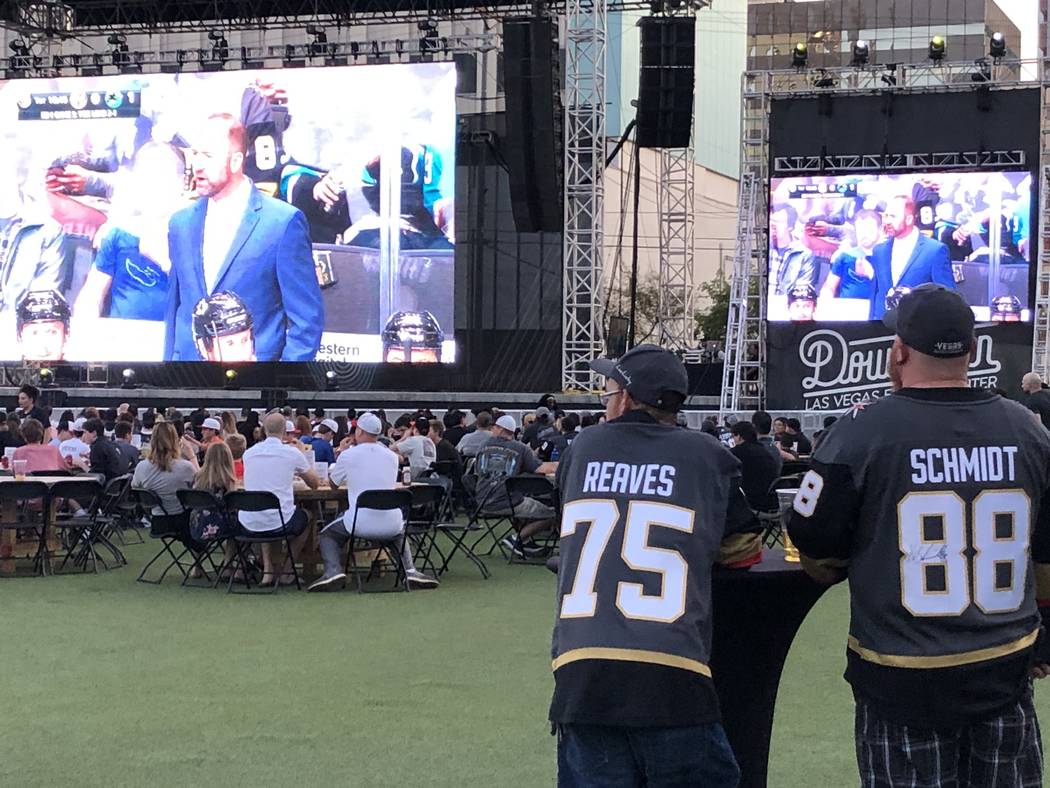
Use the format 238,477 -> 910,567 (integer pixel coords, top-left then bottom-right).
656,146 -> 696,350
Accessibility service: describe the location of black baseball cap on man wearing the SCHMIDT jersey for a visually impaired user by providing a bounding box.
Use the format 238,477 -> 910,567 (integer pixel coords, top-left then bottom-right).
882,284 -> 973,358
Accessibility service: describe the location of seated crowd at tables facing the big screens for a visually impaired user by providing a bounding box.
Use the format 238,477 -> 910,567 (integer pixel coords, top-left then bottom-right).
0,386 -> 830,590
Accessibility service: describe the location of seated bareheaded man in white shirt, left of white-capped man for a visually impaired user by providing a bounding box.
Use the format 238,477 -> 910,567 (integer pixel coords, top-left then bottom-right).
238,413 -> 318,585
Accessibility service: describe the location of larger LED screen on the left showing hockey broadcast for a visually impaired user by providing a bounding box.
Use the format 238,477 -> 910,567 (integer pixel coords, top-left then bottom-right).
0,63 -> 456,364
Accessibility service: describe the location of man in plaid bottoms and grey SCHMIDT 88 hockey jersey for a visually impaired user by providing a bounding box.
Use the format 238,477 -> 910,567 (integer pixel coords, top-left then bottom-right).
789,285 -> 1050,788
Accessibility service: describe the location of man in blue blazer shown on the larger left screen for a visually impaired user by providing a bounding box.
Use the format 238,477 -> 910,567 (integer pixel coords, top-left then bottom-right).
164,113 -> 324,361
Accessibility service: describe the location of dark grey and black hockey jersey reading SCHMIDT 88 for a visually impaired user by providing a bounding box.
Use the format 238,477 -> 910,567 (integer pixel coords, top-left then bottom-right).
790,389 -> 1050,725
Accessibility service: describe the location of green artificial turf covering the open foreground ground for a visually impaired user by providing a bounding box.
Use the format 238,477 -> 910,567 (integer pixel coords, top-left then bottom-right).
0,544 -> 1050,788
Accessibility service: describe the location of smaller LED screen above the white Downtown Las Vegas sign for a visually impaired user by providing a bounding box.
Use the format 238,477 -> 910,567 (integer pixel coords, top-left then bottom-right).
768,171 -> 1032,323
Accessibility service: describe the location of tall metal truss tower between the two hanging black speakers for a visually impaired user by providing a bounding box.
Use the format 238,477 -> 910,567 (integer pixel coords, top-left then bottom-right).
562,0 -> 607,391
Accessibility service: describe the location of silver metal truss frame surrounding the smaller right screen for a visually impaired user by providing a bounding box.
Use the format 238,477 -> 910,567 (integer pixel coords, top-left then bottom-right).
720,60 -> 1050,413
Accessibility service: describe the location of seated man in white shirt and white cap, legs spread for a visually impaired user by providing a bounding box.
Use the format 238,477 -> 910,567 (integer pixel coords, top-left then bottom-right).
308,413 -> 438,592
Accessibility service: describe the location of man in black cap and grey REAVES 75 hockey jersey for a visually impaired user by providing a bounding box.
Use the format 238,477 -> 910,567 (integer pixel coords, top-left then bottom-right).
550,345 -> 750,788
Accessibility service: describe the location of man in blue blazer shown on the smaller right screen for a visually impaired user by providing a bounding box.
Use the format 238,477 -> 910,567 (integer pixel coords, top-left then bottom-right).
870,195 -> 956,320
